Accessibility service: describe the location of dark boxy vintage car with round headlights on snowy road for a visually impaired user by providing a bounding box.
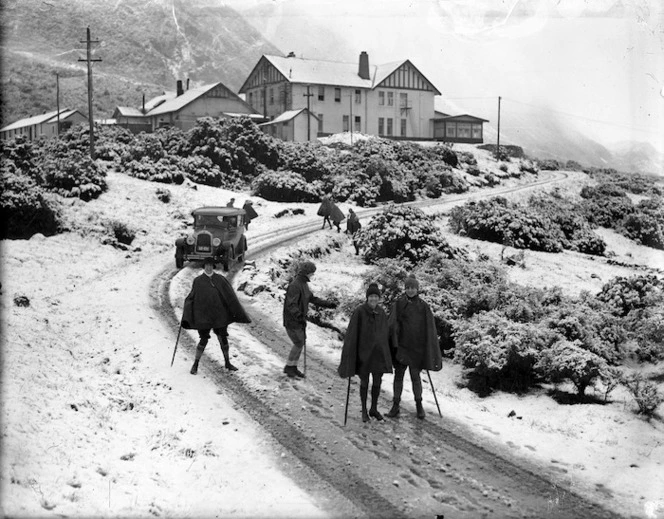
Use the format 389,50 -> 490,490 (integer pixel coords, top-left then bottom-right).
175,207 -> 247,271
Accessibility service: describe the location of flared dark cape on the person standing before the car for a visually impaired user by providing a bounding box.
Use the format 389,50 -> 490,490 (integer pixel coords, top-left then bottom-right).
182,272 -> 251,330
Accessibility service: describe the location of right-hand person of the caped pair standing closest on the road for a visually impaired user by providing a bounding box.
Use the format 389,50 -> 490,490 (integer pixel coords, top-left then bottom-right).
387,275 -> 443,419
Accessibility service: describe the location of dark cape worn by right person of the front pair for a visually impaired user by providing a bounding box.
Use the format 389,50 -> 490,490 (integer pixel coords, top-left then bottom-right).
389,294 -> 443,371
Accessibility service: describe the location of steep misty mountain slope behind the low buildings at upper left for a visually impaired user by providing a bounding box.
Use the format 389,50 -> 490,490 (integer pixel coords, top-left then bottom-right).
0,0 -> 281,125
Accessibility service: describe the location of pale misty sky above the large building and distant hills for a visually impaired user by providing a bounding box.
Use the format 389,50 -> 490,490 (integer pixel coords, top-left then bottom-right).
223,0 -> 664,153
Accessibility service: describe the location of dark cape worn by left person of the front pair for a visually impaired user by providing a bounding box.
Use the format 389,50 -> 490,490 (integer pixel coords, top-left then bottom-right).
337,303 -> 392,378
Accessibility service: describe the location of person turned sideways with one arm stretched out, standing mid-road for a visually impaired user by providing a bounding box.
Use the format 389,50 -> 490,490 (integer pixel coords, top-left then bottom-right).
283,261 -> 336,378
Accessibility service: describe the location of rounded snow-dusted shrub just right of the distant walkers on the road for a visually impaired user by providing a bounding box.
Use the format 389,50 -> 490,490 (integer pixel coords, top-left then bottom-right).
357,205 -> 461,265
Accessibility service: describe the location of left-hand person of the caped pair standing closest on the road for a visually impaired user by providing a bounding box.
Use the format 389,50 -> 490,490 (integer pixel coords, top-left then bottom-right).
337,283 -> 392,422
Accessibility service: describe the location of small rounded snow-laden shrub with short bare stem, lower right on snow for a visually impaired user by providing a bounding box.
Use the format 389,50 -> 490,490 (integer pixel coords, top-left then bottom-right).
536,340 -> 607,397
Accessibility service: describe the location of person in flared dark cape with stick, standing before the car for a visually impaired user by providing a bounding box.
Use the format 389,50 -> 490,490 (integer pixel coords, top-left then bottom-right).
182,258 -> 251,375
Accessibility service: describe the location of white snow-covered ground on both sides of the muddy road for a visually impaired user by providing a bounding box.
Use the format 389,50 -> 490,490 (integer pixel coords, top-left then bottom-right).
0,159 -> 664,518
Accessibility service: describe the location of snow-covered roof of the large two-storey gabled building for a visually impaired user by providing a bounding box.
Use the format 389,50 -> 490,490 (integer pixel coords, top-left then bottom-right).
239,54 -> 440,95
